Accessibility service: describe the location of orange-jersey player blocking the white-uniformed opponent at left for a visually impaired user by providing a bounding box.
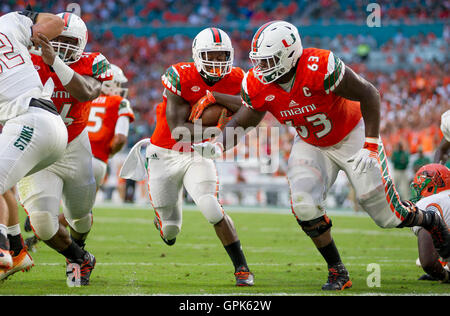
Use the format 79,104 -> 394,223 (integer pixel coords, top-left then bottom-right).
18,13 -> 112,286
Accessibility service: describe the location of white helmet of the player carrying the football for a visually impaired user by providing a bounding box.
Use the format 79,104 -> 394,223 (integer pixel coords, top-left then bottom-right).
192,27 -> 234,79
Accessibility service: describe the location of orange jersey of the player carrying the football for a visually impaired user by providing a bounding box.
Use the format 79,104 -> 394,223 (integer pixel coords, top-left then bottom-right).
151,63 -> 244,151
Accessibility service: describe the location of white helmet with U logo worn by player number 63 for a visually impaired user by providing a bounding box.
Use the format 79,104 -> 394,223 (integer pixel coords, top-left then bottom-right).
249,21 -> 303,84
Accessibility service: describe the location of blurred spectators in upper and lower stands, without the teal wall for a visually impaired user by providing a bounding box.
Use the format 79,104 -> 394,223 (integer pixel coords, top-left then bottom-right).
0,0 -> 450,207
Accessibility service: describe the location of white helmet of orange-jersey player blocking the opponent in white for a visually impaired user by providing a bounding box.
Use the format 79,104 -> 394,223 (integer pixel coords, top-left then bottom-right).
51,12 -> 88,64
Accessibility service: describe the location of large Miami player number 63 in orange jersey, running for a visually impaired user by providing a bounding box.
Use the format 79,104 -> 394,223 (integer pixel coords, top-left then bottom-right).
193,21 -> 450,290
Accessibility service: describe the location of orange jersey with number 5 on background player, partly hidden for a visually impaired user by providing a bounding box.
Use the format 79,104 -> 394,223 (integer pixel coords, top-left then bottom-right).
86,95 -> 134,163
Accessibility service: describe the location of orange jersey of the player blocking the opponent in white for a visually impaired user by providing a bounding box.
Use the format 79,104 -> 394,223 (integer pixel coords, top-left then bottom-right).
31,53 -> 112,142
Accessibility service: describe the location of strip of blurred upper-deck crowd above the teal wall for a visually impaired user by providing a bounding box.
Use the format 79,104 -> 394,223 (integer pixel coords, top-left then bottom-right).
4,0 -> 450,26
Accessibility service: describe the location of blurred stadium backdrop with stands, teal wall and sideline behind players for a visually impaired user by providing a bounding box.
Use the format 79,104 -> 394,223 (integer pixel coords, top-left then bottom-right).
4,0 -> 450,211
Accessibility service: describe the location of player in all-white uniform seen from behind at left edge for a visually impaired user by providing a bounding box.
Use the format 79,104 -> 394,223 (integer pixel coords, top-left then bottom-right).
0,8 -> 67,273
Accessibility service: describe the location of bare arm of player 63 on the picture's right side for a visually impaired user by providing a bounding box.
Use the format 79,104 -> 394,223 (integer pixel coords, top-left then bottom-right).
333,66 -> 381,138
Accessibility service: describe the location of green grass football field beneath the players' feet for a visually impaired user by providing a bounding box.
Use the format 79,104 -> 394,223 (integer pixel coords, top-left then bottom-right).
0,206 -> 450,295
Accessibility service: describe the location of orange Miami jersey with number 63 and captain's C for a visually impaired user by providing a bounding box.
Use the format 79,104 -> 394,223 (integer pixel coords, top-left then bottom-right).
241,48 -> 362,147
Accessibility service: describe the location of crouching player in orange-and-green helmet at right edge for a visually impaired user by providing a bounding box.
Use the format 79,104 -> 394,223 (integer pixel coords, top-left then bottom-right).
411,163 -> 450,283
